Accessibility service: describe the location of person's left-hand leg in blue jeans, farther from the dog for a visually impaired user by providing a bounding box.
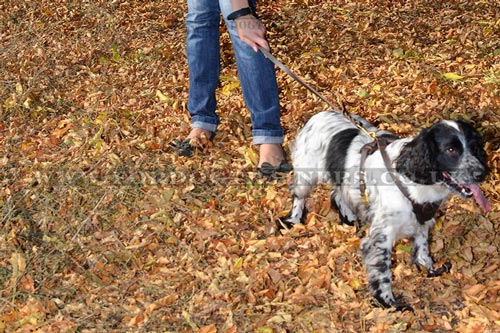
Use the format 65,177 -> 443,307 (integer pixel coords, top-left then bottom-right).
186,0 -> 221,138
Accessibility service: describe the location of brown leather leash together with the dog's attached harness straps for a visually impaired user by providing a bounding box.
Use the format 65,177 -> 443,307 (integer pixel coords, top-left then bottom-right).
259,47 -> 440,220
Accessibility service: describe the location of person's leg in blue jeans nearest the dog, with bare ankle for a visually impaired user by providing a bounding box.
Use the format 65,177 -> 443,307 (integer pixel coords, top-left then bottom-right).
219,0 -> 284,166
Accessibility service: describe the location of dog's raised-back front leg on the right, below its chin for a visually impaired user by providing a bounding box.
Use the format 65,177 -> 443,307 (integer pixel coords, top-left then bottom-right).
411,219 -> 451,277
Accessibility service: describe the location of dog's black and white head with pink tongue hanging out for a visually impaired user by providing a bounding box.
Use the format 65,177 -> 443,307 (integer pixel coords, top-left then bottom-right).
396,120 -> 489,211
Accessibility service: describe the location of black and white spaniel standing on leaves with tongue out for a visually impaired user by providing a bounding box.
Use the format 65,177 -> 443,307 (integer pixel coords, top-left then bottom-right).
281,111 -> 489,308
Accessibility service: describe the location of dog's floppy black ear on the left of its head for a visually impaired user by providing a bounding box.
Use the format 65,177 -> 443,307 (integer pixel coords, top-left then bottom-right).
396,128 -> 437,185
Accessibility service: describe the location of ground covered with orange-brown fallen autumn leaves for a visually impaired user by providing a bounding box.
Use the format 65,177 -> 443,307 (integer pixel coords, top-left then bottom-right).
0,0 -> 500,333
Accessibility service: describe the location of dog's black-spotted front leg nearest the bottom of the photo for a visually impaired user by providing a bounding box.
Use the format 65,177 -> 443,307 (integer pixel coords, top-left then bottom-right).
361,230 -> 396,308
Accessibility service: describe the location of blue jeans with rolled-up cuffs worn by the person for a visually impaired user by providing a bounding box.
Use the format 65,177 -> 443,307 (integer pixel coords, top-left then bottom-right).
186,0 -> 283,144
